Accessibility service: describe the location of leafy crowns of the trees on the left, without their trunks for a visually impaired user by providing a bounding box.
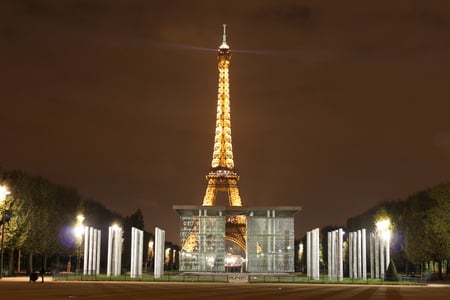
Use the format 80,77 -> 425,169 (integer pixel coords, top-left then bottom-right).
0,169 -> 151,272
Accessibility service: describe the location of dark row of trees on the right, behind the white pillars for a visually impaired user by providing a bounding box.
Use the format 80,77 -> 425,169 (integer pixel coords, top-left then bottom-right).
296,182 -> 450,278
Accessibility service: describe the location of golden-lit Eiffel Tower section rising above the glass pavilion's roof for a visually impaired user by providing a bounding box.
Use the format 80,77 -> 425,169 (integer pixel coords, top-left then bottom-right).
203,24 -> 242,206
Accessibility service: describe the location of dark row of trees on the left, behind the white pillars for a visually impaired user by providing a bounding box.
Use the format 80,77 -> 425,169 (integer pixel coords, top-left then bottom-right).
0,169 -> 153,274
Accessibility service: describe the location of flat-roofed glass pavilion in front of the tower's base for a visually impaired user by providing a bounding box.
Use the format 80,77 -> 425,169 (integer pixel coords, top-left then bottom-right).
173,205 -> 301,272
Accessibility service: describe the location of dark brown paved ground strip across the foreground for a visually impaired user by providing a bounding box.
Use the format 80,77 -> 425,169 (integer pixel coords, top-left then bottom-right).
0,278 -> 450,300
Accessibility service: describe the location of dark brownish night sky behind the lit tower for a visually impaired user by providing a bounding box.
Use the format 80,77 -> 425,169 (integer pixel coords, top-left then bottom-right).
0,0 -> 450,242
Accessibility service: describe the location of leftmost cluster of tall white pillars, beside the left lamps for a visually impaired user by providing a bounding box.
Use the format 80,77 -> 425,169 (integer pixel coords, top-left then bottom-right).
83,226 -> 101,275
